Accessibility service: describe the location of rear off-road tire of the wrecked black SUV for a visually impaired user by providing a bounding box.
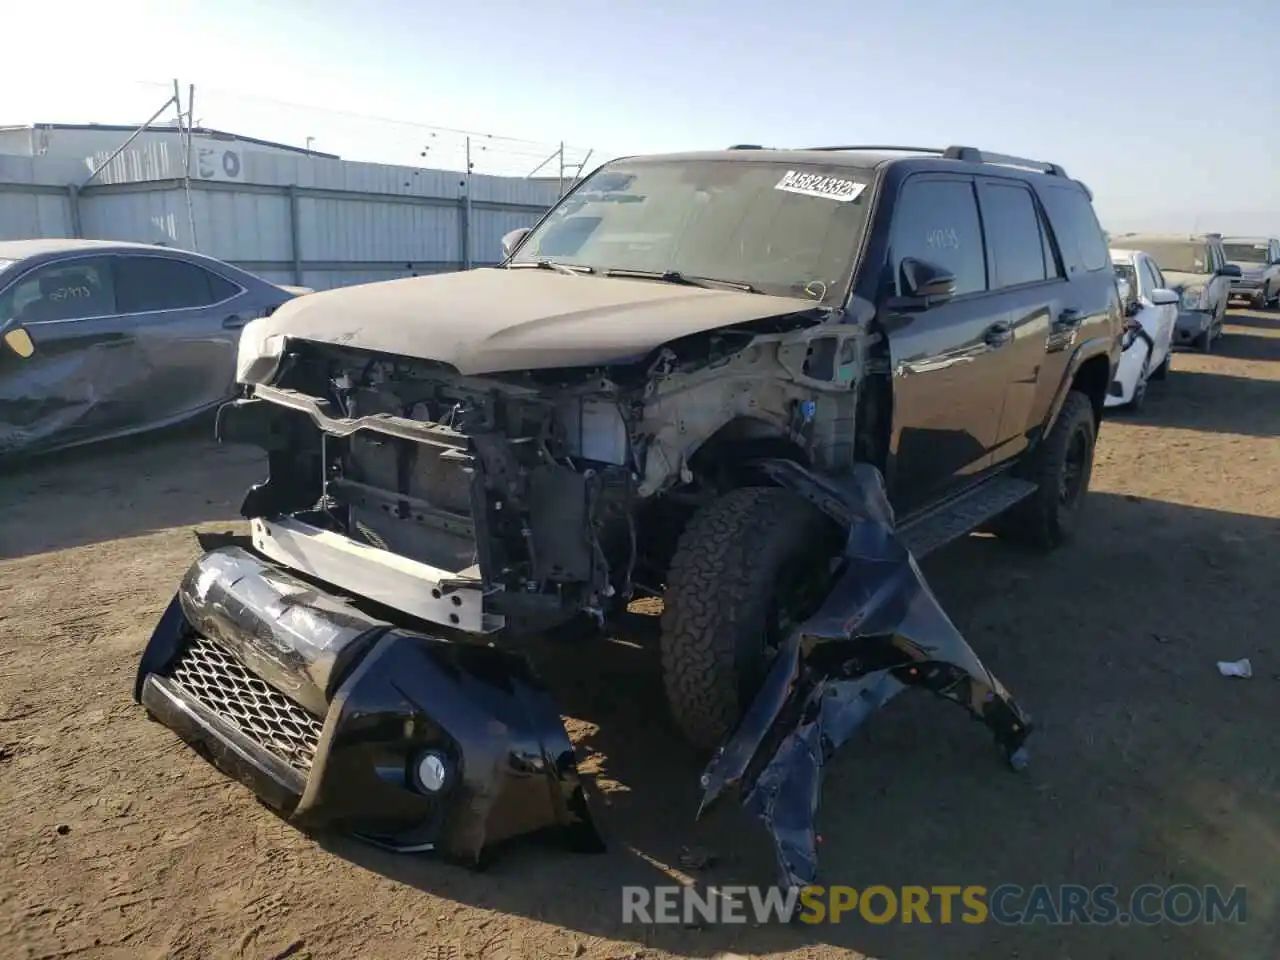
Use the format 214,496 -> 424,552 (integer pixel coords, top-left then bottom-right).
996,390 -> 1097,550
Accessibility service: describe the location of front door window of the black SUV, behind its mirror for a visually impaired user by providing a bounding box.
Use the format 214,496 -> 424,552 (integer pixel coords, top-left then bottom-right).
892,178 -> 987,297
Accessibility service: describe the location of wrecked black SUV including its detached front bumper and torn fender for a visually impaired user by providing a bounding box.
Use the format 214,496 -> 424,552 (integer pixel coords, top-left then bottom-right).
136,147 -> 1123,896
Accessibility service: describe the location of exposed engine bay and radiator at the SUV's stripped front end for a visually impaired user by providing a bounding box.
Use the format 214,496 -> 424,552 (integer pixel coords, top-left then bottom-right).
220,342 -> 641,630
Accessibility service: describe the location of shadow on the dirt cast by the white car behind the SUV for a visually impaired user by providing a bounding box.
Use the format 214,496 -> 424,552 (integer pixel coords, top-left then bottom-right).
1112,371 -> 1280,436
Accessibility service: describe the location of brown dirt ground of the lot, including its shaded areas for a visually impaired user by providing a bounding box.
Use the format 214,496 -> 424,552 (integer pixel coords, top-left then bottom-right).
0,311 -> 1280,960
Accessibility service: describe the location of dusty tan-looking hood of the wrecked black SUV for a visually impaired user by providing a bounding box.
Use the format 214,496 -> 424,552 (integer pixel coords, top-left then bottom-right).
246,268 -> 826,374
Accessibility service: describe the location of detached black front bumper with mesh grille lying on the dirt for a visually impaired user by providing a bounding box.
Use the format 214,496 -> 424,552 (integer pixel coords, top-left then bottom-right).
134,547 -> 603,864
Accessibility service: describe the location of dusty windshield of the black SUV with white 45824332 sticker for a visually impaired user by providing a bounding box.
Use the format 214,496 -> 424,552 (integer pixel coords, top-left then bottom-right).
512,160 -> 868,303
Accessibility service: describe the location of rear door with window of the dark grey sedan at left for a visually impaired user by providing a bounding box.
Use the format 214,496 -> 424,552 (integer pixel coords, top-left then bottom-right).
115,253 -> 252,422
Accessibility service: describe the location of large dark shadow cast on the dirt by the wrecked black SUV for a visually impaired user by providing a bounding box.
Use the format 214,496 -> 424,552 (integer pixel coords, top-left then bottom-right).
314,493 -> 1280,960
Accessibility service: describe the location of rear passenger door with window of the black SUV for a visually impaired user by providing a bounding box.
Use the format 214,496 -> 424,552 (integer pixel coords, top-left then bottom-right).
978,177 -> 1066,463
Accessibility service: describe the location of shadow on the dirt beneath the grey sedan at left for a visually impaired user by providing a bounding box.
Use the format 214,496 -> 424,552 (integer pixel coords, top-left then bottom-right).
0,415 -> 265,559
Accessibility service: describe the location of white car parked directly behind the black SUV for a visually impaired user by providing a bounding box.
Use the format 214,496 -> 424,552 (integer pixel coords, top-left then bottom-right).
1106,247 -> 1181,410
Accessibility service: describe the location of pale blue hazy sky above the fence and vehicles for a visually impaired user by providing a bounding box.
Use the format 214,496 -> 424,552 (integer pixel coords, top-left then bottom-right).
0,0 -> 1280,236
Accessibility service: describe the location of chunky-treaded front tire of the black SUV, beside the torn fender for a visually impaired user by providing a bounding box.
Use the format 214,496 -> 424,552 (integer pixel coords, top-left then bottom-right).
660,486 -> 838,750
